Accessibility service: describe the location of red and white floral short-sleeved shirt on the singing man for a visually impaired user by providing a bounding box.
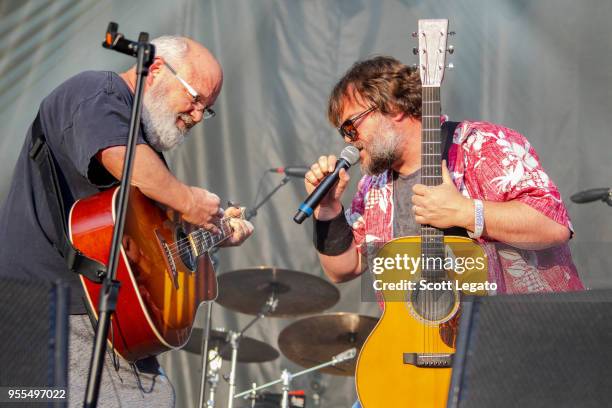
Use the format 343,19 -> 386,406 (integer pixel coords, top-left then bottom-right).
345,121 -> 584,293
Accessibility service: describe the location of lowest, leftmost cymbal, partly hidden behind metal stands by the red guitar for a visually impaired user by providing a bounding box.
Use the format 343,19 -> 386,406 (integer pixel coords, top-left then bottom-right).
182,327 -> 279,363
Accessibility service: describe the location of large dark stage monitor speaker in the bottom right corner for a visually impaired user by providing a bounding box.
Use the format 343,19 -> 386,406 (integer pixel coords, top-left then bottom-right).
448,290 -> 612,408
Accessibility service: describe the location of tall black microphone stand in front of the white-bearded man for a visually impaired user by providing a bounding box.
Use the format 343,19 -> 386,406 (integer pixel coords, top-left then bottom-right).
83,22 -> 155,408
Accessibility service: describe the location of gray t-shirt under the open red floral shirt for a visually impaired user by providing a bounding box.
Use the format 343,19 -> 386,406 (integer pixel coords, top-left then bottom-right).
393,169 -> 421,238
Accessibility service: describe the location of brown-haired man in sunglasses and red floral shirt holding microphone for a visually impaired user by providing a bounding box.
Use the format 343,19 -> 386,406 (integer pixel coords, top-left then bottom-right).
305,57 -> 583,293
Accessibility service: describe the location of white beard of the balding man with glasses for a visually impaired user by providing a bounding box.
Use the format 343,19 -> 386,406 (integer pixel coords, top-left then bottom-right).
142,84 -> 191,152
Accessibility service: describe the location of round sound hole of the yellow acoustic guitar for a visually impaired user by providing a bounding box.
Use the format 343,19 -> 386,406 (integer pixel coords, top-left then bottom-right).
410,286 -> 457,323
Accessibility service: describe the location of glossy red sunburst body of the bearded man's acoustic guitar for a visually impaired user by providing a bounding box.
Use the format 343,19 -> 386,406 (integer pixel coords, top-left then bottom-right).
69,187 -> 217,362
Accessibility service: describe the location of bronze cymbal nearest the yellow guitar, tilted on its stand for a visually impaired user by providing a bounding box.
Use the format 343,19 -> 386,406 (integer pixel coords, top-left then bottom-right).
278,313 -> 378,376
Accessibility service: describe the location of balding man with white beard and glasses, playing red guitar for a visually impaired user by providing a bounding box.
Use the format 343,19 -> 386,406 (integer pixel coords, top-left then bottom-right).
0,36 -> 253,406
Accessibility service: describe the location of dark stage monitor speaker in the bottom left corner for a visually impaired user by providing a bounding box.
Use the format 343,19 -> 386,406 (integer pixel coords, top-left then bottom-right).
0,278 -> 70,388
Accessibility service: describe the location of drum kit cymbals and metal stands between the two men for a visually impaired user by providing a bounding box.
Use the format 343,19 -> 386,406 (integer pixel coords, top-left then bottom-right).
183,267 -> 378,408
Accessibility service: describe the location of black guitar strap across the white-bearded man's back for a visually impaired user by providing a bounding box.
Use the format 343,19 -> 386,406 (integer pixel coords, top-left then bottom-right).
29,114 -> 106,283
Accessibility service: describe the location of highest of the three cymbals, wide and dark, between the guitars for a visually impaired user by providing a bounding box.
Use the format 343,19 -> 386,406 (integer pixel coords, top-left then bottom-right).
217,266 -> 340,317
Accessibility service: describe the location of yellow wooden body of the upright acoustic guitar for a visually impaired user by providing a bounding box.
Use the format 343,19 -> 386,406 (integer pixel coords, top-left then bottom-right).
355,237 -> 487,408
